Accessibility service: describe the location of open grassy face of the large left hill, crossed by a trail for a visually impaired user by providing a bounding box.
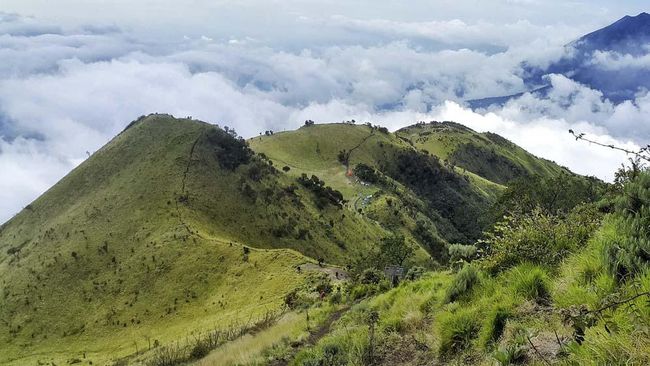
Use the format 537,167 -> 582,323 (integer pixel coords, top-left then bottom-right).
0,116 -> 382,365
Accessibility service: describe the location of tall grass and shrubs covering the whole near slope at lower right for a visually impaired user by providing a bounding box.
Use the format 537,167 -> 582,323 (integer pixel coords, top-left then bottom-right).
238,164 -> 650,365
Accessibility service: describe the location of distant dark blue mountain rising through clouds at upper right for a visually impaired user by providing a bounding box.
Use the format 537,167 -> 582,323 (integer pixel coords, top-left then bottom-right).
467,13 -> 650,109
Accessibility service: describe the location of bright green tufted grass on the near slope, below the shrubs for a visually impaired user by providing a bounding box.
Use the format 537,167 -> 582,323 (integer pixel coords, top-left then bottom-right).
292,214 -> 650,365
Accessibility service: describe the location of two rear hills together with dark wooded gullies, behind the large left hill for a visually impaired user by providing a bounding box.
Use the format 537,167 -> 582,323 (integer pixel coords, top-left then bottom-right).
249,123 -> 567,246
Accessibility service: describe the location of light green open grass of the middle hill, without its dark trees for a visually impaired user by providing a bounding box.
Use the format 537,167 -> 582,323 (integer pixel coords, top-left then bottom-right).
249,123 -> 440,263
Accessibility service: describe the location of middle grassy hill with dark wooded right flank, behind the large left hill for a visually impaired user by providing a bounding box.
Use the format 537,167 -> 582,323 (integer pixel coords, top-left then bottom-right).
249,123 -> 493,249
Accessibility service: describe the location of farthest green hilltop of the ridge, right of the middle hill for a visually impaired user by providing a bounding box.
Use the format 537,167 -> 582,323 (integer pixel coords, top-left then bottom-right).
396,122 -> 566,184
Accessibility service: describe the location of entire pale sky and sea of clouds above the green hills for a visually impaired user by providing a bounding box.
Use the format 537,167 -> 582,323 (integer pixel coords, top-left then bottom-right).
0,0 -> 650,222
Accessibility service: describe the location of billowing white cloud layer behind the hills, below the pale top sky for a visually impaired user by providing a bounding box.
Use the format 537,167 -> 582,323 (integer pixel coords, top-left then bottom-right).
0,10 -> 650,222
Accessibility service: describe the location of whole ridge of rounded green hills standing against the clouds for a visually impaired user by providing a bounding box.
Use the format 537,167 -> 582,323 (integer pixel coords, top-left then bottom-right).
0,115 -> 576,365
